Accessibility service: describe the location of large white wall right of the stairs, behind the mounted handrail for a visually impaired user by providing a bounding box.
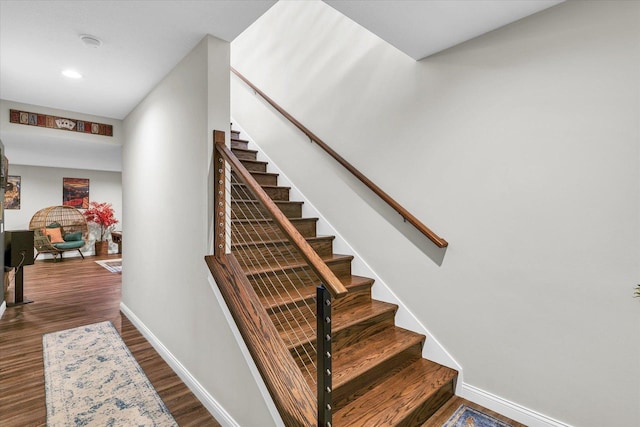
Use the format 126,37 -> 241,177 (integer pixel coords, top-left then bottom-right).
231,1 -> 640,427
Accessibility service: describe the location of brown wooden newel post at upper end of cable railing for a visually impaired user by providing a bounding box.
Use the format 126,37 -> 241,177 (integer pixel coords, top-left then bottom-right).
213,130 -> 227,258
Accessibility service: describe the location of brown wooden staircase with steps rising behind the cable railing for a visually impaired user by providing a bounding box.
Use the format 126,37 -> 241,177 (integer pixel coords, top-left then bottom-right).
231,131 -> 457,426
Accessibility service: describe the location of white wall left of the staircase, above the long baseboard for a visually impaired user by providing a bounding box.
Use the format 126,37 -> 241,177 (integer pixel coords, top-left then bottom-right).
122,36 -> 271,426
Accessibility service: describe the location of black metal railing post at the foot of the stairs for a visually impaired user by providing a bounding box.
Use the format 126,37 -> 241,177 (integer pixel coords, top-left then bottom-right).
316,285 -> 333,427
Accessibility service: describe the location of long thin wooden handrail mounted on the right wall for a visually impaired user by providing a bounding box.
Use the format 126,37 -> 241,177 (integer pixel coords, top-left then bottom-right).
231,67 -> 449,248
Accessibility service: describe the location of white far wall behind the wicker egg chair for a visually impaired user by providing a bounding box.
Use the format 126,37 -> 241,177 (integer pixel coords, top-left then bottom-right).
4,164 -> 122,259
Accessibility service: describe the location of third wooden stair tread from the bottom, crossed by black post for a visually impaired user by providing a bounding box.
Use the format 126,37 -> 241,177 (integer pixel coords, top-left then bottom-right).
280,300 -> 398,350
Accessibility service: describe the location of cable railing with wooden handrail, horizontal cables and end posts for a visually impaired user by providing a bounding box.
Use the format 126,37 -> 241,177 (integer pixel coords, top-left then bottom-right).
207,131 -> 340,426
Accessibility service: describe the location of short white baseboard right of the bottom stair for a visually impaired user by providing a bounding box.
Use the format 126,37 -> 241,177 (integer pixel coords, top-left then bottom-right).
459,384 -> 571,427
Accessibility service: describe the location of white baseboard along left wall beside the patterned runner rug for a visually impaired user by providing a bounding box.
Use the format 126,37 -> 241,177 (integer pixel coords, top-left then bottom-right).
120,302 -> 240,427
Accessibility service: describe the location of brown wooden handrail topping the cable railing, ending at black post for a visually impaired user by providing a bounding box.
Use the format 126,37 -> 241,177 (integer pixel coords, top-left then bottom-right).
214,141 -> 348,298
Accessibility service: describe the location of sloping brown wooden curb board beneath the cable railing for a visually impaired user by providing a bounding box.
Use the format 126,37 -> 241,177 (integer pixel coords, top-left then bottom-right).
205,254 -> 317,427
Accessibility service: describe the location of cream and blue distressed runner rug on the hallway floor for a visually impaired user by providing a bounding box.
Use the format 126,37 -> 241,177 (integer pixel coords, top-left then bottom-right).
42,322 -> 178,427
